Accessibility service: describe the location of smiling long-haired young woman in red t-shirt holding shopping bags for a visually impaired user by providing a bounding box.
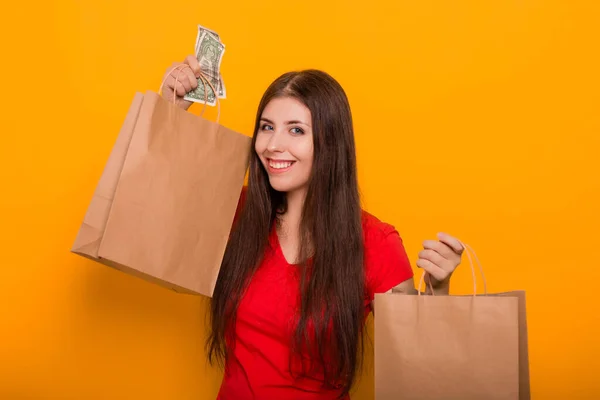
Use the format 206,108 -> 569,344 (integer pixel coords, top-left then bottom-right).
163,56 -> 463,400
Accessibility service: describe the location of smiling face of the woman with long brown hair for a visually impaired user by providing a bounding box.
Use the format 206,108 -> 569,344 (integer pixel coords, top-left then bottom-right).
254,97 -> 313,192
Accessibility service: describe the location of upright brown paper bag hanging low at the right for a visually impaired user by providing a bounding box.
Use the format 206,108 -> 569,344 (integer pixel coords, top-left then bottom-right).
375,242 -> 530,400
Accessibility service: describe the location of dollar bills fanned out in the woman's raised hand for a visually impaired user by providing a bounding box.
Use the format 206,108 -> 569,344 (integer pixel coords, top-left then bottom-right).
184,25 -> 227,106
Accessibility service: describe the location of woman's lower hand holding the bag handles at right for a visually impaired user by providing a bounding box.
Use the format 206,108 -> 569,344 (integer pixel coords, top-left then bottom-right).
417,233 -> 464,288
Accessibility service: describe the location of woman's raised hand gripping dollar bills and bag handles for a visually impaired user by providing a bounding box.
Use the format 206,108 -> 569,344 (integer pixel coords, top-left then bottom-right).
162,55 -> 200,110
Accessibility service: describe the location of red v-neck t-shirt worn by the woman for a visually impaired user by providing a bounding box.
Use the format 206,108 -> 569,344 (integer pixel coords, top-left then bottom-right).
217,193 -> 413,400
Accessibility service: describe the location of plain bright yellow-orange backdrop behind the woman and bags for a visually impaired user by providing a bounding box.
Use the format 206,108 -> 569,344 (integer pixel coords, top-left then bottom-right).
0,0 -> 600,399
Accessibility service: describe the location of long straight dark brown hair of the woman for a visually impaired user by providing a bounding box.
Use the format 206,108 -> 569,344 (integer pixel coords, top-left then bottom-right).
207,70 -> 365,395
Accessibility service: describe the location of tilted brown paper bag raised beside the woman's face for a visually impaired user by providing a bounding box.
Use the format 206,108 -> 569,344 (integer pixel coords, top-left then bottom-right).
72,71 -> 251,296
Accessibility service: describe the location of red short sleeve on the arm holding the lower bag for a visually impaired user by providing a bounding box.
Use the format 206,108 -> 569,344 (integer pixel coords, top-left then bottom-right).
364,212 -> 413,307
